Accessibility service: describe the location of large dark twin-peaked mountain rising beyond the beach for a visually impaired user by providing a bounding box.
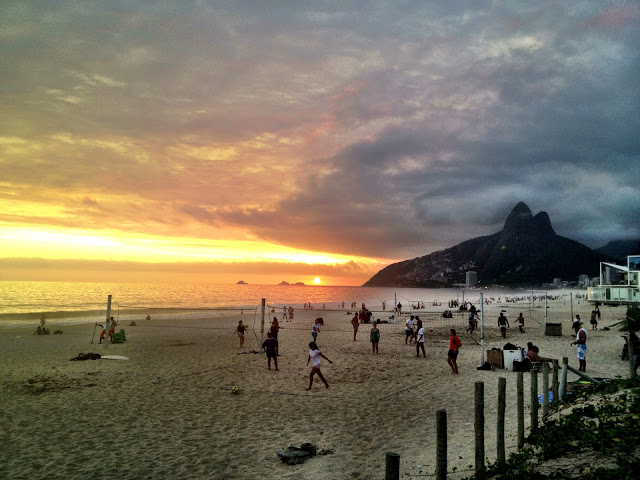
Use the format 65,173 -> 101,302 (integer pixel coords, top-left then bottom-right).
363,202 -> 612,288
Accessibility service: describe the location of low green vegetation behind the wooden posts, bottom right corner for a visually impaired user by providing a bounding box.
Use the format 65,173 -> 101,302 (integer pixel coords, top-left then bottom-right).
478,377 -> 640,480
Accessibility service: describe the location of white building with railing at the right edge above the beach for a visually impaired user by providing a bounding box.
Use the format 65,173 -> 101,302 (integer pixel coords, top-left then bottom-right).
587,255 -> 640,304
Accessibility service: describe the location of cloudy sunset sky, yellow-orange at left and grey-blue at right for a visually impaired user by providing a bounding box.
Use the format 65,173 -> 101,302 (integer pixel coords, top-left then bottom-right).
0,0 -> 640,285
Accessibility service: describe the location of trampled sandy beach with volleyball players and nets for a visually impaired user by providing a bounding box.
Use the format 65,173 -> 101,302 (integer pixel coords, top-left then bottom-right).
0,301 -> 628,479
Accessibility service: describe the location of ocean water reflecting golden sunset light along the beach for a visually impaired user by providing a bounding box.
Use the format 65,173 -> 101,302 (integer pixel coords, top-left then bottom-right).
0,281 -> 558,324
